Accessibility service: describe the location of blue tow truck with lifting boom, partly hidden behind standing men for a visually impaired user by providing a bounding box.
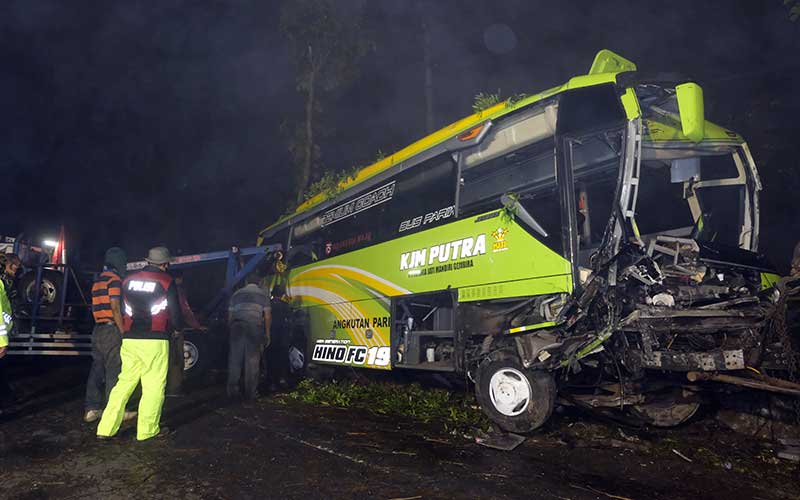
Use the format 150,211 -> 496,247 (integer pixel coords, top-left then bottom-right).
0,236 -> 282,376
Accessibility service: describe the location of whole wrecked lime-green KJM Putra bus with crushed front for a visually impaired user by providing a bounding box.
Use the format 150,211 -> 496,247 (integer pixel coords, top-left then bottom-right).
259,50 -> 776,432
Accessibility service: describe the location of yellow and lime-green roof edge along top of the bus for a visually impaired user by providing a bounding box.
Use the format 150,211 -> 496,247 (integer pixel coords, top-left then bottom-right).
259,49 -> 638,244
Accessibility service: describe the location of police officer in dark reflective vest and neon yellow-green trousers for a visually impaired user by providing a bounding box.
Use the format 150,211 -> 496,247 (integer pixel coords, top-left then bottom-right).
97,247 -> 181,441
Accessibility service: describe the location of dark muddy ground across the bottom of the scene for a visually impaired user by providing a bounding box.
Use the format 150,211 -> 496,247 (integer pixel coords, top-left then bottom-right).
0,360 -> 800,500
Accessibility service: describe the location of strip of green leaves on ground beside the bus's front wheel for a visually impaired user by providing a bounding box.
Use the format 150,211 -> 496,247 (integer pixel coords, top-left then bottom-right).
288,379 -> 489,432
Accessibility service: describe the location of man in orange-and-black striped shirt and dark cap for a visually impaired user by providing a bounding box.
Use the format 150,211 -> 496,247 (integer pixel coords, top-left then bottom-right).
83,247 -> 136,422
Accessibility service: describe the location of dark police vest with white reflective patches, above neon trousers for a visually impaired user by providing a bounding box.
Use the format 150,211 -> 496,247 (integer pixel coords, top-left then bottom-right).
122,266 -> 181,340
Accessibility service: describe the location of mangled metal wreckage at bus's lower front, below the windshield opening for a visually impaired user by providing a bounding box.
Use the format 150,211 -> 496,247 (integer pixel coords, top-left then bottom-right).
486,227 -> 800,426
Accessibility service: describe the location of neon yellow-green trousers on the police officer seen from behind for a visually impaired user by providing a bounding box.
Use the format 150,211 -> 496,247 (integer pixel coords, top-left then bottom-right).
97,339 -> 169,441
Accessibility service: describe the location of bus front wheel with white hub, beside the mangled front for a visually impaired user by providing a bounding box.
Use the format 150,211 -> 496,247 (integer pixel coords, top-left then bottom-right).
475,351 -> 556,433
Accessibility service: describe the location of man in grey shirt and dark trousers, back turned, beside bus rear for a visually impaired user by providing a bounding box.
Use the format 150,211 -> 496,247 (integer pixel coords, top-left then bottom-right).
228,274 -> 272,400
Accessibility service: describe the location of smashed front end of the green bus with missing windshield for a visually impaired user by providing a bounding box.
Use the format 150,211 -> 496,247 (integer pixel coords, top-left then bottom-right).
517,84 -> 792,425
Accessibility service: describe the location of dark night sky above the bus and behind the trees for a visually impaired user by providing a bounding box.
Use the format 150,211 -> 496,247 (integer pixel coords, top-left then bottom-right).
0,0 -> 800,267
